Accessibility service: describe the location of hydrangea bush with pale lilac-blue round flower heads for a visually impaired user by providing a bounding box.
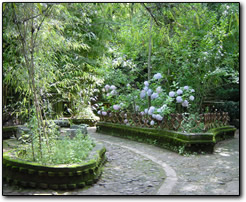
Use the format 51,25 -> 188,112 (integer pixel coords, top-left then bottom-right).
95,73 -> 195,129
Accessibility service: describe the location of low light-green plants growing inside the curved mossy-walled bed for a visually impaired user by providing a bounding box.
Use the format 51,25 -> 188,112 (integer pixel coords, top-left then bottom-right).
17,132 -> 95,165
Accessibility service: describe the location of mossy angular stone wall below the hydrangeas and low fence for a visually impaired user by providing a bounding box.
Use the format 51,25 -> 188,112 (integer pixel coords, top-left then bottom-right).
97,122 -> 236,153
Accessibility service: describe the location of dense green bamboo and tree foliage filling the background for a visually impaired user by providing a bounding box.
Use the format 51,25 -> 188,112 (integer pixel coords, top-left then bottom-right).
3,3 -> 239,161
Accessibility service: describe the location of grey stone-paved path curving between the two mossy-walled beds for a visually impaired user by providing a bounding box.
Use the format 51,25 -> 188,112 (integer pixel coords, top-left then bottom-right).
3,128 -> 239,195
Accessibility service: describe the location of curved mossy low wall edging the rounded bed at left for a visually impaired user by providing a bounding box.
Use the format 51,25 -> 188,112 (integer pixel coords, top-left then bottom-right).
3,143 -> 106,189
